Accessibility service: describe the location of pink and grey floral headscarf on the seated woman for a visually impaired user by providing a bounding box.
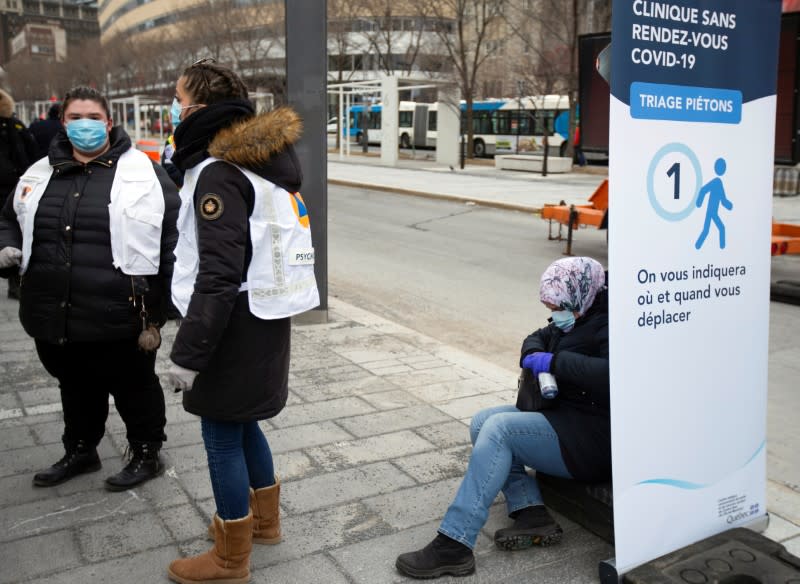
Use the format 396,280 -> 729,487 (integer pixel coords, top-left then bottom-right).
539,257 -> 606,316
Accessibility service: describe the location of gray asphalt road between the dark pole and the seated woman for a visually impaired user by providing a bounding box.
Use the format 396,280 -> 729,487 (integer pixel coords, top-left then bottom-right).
328,185 -> 607,371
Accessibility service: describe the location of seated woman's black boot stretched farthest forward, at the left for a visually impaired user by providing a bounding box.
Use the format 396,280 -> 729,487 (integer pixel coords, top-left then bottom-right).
395,533 -> 475,579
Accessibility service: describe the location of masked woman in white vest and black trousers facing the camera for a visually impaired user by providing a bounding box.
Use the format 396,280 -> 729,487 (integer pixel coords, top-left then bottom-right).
0,87 -> 180,491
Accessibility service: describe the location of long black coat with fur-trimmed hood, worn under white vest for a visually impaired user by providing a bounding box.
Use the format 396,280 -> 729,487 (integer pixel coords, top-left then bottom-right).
170,102 -> 302,422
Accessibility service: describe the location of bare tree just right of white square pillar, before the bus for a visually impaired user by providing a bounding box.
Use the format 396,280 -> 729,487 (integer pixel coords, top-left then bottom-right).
416,0 -> 504,158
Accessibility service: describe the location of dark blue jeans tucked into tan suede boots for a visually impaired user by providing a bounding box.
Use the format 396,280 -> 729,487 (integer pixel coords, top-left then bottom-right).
200,418 -> 275,520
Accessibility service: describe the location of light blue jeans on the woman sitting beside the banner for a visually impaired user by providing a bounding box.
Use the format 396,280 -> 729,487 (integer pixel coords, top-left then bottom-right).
439,406 -> 572,548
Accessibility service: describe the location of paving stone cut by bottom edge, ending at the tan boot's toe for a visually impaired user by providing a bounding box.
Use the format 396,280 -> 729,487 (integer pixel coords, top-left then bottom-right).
28,545 -> 179,584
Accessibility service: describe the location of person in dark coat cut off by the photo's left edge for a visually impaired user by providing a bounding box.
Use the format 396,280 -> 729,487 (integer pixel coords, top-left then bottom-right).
0,89 -> 38,298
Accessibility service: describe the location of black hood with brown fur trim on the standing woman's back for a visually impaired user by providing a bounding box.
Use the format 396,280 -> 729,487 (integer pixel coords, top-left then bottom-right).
208,107 -> 303,191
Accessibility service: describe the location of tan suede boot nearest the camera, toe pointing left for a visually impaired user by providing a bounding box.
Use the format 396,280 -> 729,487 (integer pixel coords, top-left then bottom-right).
167,513 -> 253,584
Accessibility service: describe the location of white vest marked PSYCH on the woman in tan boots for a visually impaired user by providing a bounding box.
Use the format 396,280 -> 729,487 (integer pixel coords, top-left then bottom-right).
172,158 -> 319,320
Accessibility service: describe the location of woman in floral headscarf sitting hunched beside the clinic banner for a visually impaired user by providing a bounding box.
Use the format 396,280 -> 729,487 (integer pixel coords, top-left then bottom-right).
396,257 -> 611,578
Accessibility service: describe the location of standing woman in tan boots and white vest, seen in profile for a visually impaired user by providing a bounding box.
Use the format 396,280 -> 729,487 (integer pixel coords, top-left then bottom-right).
165,59 -> 319,583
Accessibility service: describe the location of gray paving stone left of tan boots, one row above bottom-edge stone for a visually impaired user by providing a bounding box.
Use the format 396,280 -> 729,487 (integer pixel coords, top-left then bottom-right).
77,512 -> 171,562
